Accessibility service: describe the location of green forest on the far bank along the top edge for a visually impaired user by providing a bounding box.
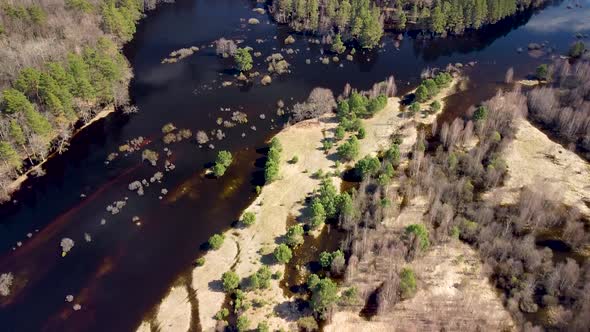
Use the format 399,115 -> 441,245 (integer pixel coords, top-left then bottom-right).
270,0 -> 542,48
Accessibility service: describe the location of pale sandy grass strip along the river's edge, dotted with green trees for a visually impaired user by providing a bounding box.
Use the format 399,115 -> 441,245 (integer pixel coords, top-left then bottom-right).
138,78 -> 460,332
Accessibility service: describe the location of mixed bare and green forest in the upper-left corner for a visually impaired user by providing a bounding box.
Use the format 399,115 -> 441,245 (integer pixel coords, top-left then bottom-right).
0,0 -> 155,198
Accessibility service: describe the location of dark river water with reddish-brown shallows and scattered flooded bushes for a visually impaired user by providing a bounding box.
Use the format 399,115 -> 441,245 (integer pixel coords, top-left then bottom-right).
0,0 -> 590,331
